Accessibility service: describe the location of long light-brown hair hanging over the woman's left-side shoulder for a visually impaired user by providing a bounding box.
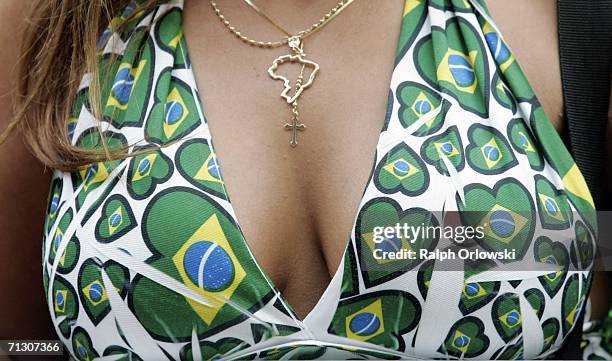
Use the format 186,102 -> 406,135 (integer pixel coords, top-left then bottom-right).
0,0 -> 160,171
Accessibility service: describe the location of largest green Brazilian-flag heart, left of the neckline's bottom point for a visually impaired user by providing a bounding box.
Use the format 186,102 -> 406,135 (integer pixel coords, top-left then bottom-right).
128,187 -> 276,342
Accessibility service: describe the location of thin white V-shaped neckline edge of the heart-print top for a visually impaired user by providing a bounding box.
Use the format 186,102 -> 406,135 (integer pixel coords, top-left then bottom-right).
178,0 -> 411,328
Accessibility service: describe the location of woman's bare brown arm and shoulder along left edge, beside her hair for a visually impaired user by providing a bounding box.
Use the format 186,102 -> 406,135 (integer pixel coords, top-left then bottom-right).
0,0 -> 56,350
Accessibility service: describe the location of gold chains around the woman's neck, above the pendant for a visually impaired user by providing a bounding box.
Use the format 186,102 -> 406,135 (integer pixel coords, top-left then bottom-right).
210,0 -> 355,48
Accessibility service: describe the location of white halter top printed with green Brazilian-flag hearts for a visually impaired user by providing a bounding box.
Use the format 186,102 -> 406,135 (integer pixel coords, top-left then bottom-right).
43,0 -> 597,360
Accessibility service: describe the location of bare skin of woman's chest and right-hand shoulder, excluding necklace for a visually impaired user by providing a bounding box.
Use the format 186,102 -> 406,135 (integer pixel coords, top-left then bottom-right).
184,0 -> 563,316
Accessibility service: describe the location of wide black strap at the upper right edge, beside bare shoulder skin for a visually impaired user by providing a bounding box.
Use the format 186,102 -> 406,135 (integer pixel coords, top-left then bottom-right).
557,0 -> 612,209
